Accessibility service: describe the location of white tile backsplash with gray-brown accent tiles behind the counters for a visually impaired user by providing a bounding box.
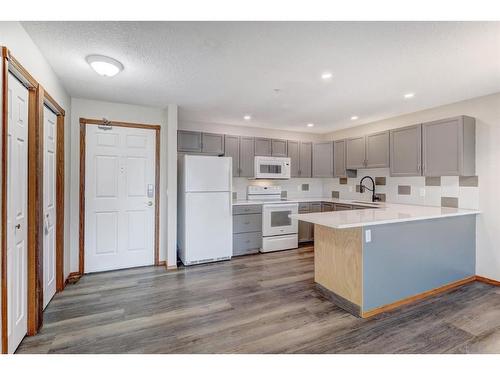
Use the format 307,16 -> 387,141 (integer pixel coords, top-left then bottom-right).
233,168 -> 479,209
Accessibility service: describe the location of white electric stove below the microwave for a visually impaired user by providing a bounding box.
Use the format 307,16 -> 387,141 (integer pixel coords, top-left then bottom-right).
247,186 -> 299,253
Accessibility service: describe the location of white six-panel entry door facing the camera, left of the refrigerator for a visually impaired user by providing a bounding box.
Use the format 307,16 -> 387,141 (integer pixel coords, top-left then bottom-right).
85,125 -> 157,273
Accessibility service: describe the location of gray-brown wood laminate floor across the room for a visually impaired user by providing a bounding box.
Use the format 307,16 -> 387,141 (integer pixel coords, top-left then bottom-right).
18,248 -> 500,353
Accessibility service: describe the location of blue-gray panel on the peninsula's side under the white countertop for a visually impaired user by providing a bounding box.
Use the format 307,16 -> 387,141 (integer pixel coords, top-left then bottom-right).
363,215 -> 476,311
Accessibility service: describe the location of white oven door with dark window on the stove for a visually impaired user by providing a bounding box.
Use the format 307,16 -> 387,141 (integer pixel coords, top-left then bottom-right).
262,203 -> 299,236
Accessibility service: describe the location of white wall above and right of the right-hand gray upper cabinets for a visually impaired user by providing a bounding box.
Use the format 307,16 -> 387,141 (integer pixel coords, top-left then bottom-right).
326,93 -> 500,280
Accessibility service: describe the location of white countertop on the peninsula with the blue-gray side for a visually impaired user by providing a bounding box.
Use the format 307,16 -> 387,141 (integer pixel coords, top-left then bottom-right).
291,203 -> 480,229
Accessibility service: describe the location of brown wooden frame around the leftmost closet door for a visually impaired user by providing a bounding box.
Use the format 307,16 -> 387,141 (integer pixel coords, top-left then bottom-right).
1,47 -> 43,353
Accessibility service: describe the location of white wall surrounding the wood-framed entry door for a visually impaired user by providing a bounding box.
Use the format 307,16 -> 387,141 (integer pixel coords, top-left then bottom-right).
70,98 -> 177,272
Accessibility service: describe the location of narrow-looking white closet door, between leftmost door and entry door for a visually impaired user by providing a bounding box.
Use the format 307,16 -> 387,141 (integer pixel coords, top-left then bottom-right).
43,107 -> 57,309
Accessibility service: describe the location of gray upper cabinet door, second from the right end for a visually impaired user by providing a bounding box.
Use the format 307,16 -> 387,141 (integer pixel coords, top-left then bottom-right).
390,124 -> 422,176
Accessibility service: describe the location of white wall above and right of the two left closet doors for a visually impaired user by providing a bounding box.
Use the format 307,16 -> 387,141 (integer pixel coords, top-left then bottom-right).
0,22 -> 71,352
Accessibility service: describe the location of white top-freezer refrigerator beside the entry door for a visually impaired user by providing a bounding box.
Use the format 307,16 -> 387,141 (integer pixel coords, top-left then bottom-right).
177,155 -> 233,265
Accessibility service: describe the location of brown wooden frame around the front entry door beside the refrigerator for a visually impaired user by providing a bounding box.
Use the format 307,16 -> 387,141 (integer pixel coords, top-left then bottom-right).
77,118 -> 163,282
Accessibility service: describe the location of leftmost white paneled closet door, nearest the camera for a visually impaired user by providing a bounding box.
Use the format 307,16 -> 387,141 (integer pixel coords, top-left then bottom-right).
7,73 -> 28,353
